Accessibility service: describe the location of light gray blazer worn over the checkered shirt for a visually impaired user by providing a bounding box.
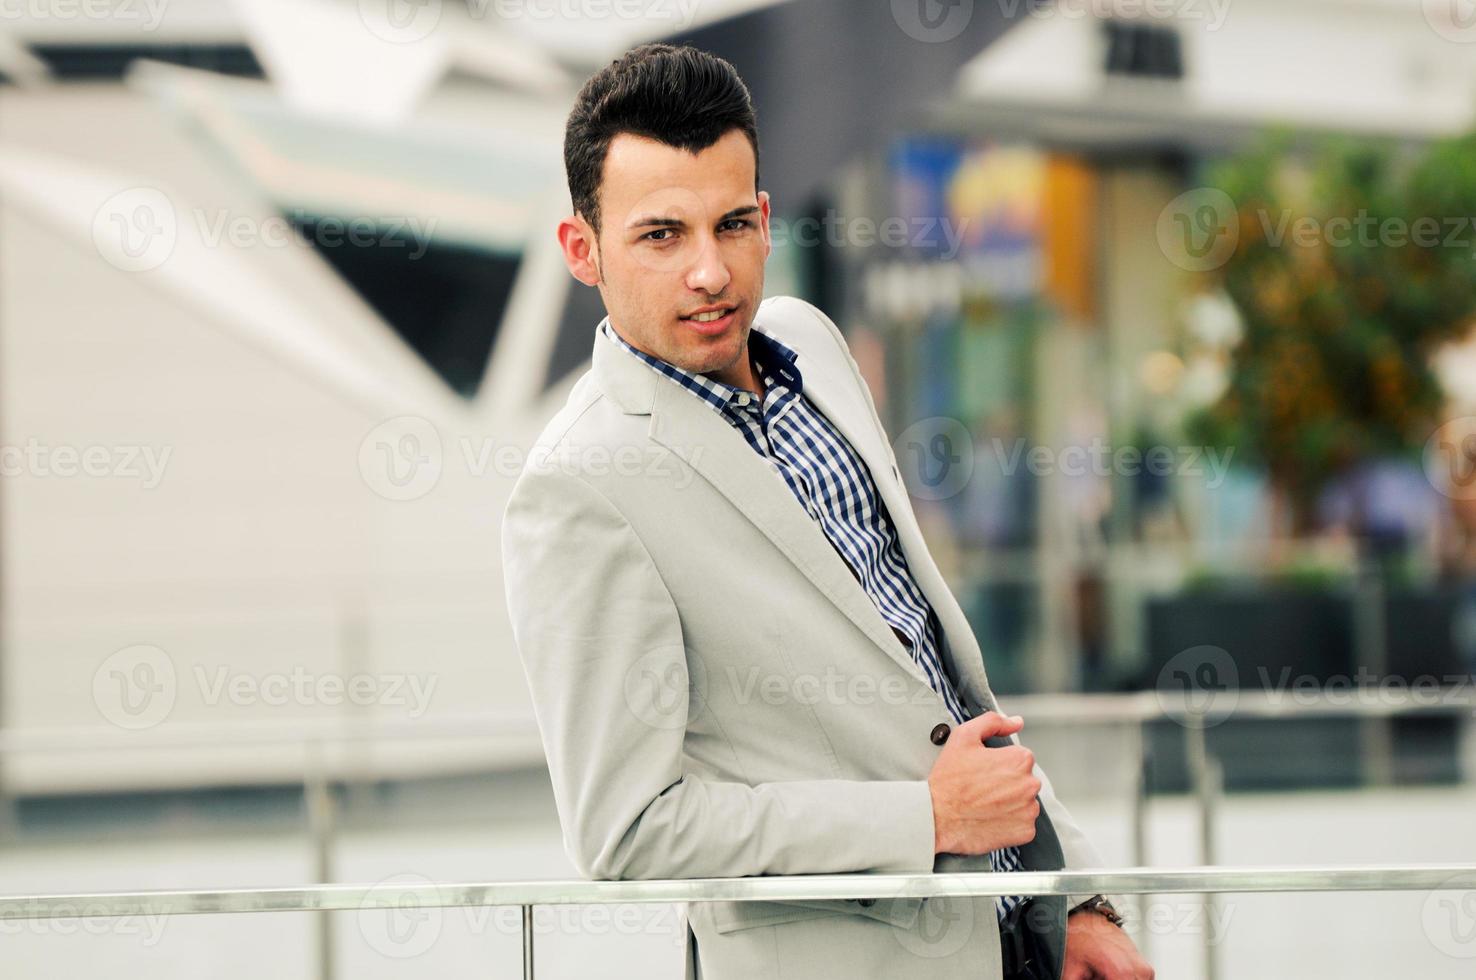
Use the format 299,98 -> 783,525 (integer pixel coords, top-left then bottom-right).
502,297 -> 1098,980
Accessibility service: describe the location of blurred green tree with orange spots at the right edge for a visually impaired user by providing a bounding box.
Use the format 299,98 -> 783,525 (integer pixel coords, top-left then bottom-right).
1190,129 -> 1476,533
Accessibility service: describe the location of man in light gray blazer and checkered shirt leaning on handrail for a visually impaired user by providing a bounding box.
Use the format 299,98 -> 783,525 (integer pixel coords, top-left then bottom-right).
502,44 -> 1153,980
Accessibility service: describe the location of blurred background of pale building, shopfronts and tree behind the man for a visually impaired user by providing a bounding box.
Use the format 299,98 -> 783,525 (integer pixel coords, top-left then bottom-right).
0,0 -> 1476,980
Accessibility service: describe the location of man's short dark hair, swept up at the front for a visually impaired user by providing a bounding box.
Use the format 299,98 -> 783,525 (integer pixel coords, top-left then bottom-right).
564,43 -> 759,235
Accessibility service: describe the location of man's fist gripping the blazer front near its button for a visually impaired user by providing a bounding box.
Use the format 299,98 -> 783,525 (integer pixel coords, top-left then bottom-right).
927,711 -> 1041,855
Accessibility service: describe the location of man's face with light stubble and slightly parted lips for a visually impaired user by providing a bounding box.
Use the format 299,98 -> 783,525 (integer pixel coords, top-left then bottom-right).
559,130 -> 770,384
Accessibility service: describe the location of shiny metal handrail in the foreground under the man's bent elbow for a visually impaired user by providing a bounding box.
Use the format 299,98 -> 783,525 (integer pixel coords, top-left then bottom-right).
0,863 -> 1476,919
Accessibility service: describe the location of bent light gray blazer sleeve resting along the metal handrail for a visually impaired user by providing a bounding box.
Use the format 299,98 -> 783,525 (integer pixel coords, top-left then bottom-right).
502,466 -> 934,880
